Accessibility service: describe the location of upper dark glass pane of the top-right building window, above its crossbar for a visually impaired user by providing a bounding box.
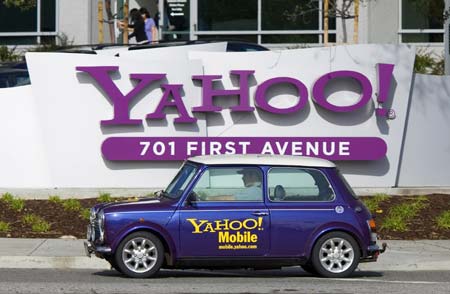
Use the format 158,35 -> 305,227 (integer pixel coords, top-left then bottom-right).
402,0 -> 444,29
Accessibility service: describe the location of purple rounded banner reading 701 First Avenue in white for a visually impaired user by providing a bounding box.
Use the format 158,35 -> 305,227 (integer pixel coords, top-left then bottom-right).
102,137 -> 387,161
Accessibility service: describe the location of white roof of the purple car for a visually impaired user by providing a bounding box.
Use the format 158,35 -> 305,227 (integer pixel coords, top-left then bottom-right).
188,154 -> 336,167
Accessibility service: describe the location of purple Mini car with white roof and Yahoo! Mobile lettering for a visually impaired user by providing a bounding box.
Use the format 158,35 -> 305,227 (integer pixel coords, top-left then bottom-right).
85,155 -> 385,278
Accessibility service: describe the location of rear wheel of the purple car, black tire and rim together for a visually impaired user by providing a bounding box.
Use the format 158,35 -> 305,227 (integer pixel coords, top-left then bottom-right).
311,232 -> 361,278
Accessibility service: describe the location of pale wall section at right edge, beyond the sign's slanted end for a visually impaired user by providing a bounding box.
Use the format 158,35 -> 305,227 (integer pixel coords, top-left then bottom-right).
398,74 -> 450,187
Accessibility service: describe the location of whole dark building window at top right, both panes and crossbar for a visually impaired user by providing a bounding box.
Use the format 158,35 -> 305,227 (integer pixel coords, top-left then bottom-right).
399,0 -> 445,43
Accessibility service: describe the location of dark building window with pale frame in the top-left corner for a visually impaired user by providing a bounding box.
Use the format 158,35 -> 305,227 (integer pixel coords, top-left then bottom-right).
0,0 -> 57,45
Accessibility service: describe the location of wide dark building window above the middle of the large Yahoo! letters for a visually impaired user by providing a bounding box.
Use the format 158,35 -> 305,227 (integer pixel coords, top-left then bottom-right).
194,0 -> 336,44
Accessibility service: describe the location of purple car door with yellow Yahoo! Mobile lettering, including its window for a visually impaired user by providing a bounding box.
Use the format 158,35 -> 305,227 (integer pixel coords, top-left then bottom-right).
179,167 -> 270,257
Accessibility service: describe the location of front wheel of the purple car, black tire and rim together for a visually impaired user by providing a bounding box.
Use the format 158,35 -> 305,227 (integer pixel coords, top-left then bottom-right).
114,231 -> 164,278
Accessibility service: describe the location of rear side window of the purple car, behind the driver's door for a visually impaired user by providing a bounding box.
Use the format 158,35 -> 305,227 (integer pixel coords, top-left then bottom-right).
267,167 -> 334,201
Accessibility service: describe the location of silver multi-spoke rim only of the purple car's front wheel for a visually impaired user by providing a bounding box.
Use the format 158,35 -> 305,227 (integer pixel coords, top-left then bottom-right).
122,237 -> 158,273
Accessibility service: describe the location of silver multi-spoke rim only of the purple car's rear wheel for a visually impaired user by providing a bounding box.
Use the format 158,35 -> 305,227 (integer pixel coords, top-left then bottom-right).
319,238 -> 355,274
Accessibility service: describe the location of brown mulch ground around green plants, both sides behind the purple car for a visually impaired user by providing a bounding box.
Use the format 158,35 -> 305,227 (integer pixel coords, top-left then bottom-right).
0,194 -> 450,240
